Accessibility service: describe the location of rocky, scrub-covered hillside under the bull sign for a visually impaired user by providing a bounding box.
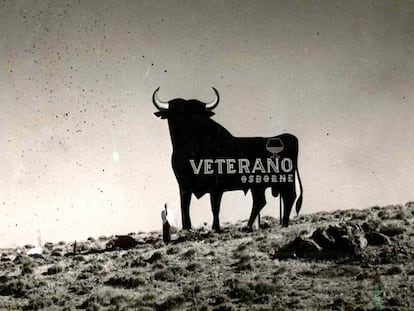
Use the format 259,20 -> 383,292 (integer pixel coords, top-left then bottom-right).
0,202 -> 414,311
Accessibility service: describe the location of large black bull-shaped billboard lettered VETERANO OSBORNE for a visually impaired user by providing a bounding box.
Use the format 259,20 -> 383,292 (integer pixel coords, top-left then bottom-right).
152,88 -> 303,231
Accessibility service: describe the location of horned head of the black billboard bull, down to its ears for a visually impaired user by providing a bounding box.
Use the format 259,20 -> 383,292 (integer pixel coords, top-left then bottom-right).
152,87 -> 220,119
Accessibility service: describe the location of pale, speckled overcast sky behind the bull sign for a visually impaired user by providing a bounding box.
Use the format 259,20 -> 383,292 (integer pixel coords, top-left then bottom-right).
0,0 -> 414,247
